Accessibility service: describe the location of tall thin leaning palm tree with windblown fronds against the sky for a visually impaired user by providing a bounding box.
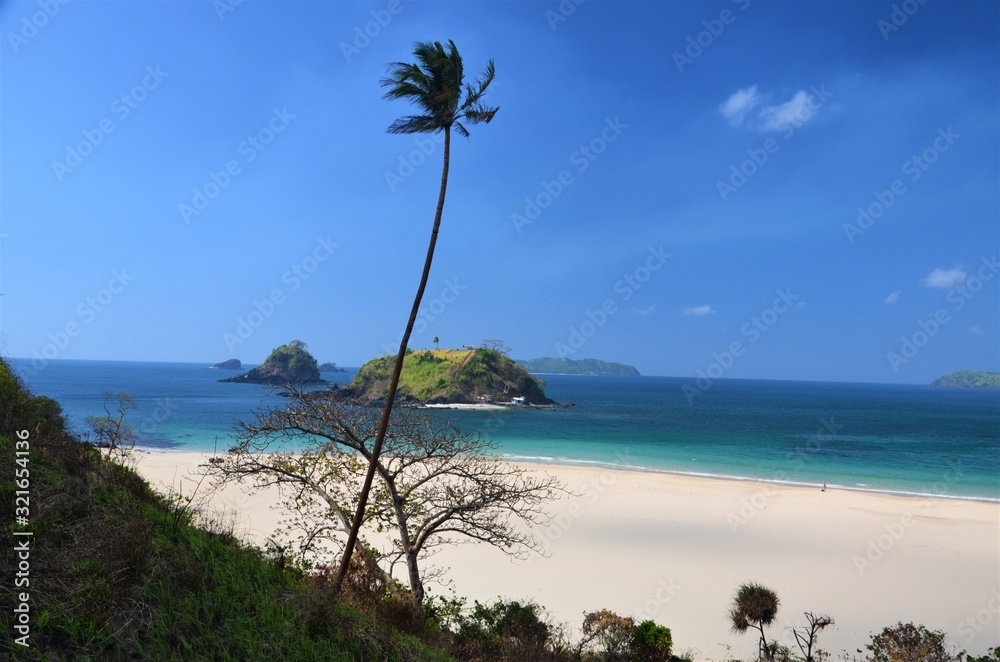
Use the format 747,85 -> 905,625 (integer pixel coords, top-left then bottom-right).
333,40 -> 499,606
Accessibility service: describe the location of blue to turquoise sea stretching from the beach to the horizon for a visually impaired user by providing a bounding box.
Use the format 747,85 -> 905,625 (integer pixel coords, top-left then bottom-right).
12,359 -> 1000,500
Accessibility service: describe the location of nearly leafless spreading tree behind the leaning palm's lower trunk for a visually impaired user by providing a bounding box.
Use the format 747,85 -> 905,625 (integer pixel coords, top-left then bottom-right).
209,391 -> 564,605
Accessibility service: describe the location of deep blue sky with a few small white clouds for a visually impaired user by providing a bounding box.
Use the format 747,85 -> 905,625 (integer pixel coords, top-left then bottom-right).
0,0 -> 1000,383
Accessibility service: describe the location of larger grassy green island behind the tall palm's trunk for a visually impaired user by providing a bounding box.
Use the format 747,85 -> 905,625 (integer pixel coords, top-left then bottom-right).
337,347 -> 572,407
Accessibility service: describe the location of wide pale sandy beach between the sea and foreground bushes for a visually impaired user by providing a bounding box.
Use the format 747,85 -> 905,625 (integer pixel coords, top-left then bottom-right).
139,453 -> 1000,660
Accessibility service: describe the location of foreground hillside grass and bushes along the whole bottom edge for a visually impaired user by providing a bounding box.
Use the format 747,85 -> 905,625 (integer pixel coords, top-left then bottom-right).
0,359 -> 1000,662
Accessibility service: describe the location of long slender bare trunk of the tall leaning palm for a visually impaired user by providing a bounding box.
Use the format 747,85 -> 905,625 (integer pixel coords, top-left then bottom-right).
333,126 -> 451,593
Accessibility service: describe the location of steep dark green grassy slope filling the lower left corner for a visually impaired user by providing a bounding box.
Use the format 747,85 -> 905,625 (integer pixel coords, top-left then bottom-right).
0,361 -> 452,660
